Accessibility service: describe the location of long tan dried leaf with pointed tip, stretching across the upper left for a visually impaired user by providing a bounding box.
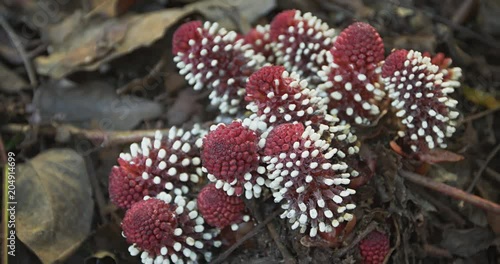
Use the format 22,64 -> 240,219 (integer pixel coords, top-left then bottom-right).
35,8 -> 192,79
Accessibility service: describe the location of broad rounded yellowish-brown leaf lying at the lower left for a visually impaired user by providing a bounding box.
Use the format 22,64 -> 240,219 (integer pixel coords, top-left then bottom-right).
16,149 -> 94,263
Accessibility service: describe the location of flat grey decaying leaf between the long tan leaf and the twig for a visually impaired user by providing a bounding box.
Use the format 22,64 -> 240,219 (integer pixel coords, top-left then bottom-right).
33,80 -> 163,130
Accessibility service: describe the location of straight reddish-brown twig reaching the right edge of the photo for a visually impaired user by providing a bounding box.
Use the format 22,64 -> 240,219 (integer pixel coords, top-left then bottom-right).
399,170 -> 500,214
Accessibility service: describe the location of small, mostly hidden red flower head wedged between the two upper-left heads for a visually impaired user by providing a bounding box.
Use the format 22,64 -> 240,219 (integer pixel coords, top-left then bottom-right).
245,25 -> 276,64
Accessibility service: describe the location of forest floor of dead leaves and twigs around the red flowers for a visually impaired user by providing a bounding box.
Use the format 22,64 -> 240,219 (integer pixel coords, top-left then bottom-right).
0,0 -> 500,264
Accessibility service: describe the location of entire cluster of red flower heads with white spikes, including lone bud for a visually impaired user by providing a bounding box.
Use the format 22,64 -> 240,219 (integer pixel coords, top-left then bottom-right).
109,10 -> 461,263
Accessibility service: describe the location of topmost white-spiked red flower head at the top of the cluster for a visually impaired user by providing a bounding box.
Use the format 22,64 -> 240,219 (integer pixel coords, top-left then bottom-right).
271,10 -> 335,81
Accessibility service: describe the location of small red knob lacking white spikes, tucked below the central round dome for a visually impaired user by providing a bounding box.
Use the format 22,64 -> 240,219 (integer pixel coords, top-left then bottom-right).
198,183 -> 245,229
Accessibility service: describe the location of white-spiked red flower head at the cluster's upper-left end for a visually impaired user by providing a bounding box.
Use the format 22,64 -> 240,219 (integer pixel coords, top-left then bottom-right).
173,21 -> 264,114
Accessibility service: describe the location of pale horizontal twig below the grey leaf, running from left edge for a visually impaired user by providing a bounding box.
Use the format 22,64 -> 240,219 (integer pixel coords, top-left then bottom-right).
0,124 -> 168,147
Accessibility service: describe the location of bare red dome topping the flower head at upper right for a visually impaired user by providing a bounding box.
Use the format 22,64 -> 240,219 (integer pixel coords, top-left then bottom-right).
331,22 -> 384,70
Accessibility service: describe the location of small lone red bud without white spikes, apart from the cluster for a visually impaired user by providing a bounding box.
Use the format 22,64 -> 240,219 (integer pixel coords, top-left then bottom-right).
359,231 -> 390,264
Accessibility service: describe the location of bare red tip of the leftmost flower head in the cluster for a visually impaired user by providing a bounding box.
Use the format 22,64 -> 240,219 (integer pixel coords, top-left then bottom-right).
109,165 -> 164,209
